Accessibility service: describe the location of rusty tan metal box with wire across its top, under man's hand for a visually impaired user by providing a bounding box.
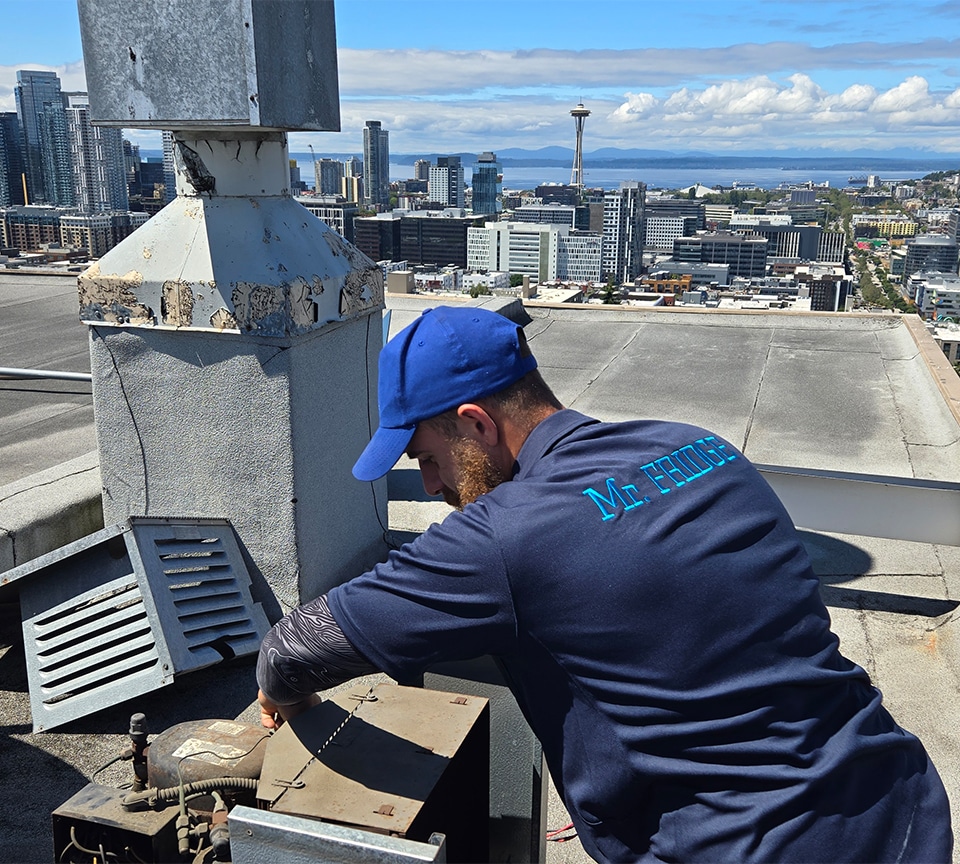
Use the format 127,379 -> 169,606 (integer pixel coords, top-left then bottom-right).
257,684 -> 489,860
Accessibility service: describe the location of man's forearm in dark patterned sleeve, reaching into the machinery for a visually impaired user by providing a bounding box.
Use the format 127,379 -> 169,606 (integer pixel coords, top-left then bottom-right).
257,595 -> 377,728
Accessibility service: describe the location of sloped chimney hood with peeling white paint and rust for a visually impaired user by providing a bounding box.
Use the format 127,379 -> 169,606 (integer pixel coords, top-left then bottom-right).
78,197 -> 384,337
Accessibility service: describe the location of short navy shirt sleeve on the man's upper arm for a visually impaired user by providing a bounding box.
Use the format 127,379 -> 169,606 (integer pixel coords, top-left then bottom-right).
328,496 -> 517,683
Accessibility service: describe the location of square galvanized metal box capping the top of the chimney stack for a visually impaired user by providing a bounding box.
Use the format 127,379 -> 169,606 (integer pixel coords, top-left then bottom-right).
79,0 -> 340,132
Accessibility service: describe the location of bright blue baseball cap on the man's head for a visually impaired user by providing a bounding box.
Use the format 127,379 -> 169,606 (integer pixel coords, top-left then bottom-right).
353,306 -> 537,480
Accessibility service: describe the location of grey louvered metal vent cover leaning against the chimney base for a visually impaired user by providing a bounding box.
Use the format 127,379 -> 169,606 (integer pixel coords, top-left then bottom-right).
5,517 -> 269,732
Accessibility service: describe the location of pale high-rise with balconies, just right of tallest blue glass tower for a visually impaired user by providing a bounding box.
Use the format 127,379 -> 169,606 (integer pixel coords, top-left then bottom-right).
63,93 -> 130,213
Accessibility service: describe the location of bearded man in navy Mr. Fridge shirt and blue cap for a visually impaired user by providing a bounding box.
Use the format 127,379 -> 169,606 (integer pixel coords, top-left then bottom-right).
258,307 -> 952,862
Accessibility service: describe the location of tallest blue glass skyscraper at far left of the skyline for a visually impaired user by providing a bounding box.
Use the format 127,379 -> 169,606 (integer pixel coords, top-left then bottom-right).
13,69 -> 64,204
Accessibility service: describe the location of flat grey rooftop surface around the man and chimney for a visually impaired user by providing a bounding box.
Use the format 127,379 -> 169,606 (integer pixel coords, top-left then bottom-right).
0,274 -> 960,861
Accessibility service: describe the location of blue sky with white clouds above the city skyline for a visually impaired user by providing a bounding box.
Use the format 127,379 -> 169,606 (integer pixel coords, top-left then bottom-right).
0,0 -> 960,156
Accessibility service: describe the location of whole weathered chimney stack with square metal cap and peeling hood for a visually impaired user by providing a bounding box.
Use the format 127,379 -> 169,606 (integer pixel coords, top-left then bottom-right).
79,0 -> 387,607
